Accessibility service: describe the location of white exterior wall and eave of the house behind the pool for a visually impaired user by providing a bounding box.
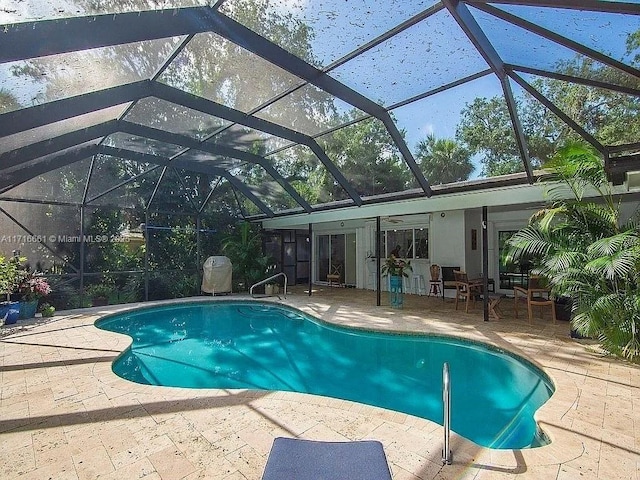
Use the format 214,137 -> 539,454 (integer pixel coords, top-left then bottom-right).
263,185 -> 640,295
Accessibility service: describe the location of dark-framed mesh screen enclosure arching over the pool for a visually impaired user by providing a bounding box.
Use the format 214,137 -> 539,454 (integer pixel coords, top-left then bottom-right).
0,0 -> 640,304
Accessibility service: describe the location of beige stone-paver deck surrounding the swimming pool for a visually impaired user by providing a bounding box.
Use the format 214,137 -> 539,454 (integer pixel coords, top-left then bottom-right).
0,288 -> 640,480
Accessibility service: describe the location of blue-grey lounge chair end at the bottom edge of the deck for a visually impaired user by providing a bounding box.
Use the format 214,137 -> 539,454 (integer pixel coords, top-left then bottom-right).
262,437 -> 391,480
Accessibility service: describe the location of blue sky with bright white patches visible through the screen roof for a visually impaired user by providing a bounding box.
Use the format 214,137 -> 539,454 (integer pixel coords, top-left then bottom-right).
0,0 -> 640,181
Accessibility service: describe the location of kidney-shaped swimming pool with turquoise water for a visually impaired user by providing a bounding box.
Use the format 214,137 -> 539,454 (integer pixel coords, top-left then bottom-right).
96,301 -> 553,448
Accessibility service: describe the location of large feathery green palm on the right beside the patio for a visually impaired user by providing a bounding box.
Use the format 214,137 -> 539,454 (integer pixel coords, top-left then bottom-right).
508,144 -> 640,361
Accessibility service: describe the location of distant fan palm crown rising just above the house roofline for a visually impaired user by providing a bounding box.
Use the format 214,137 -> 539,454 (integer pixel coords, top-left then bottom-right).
416,134 -> 474,185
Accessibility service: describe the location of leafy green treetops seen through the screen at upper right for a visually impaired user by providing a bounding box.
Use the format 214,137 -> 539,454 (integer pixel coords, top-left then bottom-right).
456,31 -> 640,176
